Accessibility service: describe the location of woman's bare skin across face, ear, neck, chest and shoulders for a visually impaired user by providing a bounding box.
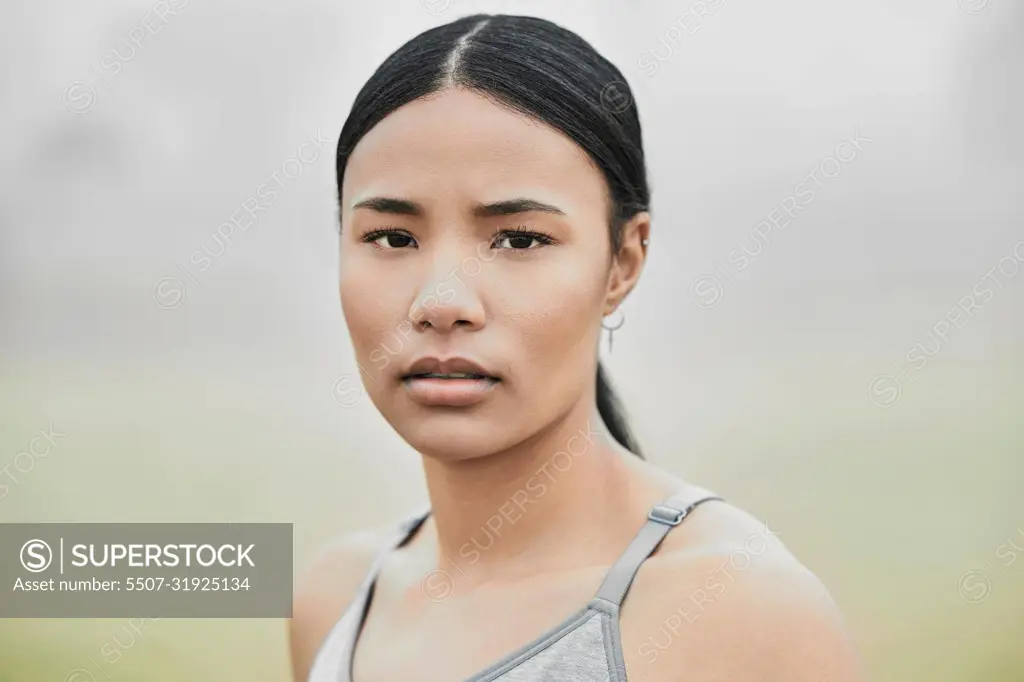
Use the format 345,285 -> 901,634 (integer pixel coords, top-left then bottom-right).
291,89 -> 861,682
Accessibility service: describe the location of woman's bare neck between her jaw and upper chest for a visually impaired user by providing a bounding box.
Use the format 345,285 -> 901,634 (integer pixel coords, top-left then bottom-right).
415,401 -> 675,587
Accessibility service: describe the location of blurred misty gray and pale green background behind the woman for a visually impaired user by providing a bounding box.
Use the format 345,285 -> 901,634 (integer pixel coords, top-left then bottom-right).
0,0 -> 1024,682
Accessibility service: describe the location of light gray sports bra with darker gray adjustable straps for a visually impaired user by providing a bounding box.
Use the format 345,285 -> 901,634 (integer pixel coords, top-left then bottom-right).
308,494 -> 722,682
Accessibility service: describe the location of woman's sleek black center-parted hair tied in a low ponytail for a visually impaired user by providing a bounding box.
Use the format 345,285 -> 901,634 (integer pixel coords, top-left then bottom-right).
337,14 -> 650,458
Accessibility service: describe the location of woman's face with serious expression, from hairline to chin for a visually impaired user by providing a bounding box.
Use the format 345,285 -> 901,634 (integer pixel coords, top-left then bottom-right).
340,84 -> 645,460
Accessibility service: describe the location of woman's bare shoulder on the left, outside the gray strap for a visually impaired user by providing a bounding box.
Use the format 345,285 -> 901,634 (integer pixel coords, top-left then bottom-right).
289,521 -> 415,681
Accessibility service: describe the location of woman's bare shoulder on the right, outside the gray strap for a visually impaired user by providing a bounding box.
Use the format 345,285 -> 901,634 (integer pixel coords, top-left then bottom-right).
623,493 -> 862,682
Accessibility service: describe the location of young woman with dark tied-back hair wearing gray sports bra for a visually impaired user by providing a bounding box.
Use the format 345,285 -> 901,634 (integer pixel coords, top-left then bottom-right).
291,10 -> 859,682
